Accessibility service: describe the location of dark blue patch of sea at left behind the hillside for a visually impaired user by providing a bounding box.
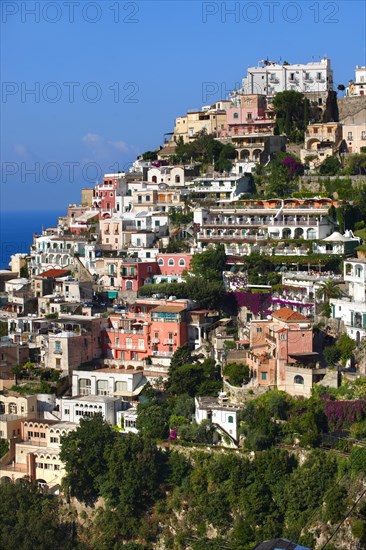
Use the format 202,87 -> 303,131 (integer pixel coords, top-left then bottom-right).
0,210 -> 65,269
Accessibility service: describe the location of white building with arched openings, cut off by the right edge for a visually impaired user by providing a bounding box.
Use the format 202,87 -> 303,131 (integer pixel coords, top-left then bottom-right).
330,258 -> 366,345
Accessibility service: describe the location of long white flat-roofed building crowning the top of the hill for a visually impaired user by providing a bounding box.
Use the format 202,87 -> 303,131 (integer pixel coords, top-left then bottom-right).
241,58 -> 333,96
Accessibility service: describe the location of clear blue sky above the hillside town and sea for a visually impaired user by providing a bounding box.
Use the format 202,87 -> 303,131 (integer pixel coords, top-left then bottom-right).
0,0 -> 366,211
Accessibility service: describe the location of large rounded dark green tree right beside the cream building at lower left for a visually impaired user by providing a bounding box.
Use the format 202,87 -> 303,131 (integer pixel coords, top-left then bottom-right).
60,414 -> 116,505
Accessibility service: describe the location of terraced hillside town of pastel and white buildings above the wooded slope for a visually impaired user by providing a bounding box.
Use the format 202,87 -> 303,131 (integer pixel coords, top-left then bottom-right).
0,58 -> 366,550
